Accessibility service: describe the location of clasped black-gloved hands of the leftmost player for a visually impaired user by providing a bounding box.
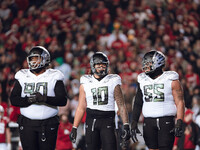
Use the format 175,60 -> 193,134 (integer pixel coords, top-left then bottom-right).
28,92 -> 47,104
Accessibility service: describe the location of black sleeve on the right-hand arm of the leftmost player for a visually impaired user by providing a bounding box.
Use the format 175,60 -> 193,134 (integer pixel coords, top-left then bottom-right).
46,80 -> 67,106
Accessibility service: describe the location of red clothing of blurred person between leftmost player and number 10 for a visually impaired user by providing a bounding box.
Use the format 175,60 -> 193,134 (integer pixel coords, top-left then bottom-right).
56,121 -> 73,150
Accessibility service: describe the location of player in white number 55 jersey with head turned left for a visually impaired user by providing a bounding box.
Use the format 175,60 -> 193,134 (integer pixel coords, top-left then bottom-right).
131,50 -> 185,150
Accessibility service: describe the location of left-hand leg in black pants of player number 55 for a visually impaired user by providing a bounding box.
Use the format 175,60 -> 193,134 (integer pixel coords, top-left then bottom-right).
143,118 -> 158,150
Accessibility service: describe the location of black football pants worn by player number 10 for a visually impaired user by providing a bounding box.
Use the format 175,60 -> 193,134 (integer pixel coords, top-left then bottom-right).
86,118 -> 117,150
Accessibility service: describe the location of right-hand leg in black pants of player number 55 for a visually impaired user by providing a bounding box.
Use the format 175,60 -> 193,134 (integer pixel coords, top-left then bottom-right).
158,117 -> 174,150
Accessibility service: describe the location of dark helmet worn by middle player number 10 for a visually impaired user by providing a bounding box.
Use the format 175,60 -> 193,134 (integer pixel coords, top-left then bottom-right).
90,52 -> 109,76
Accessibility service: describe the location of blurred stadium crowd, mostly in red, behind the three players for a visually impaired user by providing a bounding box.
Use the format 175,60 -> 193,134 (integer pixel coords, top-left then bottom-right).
0,0 -> 200,149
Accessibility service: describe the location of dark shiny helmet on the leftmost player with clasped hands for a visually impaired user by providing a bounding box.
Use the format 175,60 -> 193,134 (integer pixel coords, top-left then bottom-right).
27,46 -> 50,70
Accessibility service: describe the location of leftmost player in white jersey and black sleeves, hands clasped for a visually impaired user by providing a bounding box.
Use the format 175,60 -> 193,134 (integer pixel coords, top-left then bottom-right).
10,46 -> 67,150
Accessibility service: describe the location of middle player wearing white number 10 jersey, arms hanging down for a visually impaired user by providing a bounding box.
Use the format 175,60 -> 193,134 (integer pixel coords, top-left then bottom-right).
70,52 -> 130,150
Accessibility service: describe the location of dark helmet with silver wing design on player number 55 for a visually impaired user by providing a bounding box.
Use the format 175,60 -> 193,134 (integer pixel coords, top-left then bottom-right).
142,50 -> 165,75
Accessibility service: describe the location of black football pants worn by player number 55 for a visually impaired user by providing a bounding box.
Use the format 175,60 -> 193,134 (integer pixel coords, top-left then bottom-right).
143,116 -> 174,150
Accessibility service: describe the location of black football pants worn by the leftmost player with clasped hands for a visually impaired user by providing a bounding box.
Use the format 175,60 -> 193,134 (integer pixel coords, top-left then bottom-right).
19,115 -> 59,150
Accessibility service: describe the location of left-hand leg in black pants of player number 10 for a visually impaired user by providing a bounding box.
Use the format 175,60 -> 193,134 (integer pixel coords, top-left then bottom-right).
85,118 -> 101,150
